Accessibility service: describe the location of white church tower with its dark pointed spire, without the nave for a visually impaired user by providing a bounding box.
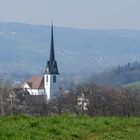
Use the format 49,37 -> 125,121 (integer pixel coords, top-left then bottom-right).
44,25 -> 59,100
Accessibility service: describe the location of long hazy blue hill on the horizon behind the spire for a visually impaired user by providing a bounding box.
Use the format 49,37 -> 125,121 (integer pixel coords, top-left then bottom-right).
0,22 -> 140,80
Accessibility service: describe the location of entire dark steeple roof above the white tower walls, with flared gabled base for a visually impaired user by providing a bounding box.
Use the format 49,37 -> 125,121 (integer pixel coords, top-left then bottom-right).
45,25 -> 59,74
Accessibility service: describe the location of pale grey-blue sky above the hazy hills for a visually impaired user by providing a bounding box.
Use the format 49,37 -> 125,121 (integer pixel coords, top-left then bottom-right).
0,0 -> 140,30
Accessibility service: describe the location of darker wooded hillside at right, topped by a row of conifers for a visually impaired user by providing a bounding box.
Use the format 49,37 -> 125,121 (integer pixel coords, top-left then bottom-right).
90,61 -> 140,87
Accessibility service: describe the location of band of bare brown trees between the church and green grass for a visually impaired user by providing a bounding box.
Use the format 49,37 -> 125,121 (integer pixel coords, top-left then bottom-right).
0,80 -> 140,116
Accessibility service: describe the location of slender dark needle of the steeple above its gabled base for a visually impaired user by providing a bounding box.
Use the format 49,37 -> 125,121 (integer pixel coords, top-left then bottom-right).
50,23 -> 55,65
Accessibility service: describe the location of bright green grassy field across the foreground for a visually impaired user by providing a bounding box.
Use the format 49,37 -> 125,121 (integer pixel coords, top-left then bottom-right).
0,115 -> 140,140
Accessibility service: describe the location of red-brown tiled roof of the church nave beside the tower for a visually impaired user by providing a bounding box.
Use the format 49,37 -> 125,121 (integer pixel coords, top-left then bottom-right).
26,76 -> 44,89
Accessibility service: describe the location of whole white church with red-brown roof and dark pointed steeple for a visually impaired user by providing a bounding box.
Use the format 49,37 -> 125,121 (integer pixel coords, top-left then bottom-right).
23,25 -> 59,100
